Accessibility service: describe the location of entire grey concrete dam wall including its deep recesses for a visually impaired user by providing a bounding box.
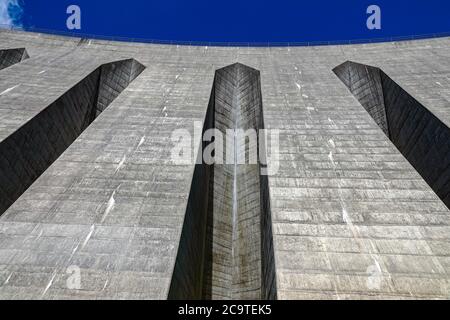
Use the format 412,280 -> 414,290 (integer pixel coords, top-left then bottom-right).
0,30 -> 450,300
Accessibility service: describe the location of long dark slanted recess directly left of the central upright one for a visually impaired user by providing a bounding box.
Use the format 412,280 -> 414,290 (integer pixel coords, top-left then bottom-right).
0,59 -> 145,214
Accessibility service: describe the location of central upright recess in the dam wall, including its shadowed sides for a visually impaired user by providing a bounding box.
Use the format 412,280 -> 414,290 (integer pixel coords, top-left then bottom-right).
168,64 -> 276,299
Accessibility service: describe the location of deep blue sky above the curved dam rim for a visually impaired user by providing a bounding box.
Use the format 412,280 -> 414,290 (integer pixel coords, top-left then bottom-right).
0,0 -> 450,42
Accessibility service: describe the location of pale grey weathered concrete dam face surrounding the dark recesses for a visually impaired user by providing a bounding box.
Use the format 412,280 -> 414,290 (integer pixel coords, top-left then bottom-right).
0,31 -> 450,299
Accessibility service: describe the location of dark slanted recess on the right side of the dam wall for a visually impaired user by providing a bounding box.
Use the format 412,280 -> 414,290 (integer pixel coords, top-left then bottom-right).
333,61 -> 450,208
